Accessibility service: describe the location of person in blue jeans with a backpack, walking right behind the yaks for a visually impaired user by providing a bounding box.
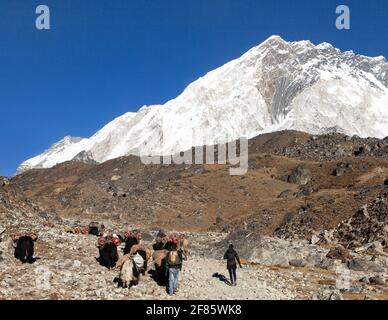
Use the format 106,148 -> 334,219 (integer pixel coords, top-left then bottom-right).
166,238 -> 185,296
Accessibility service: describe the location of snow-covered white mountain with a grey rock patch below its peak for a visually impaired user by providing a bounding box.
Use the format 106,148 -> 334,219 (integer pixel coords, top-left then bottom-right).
18,36 -> 388,173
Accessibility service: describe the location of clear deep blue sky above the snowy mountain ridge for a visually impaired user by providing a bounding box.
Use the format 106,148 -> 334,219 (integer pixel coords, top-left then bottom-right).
0,0 -> 388,175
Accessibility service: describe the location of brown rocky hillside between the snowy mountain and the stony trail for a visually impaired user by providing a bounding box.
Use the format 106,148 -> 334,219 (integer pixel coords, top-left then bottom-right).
11,131 -> 388,239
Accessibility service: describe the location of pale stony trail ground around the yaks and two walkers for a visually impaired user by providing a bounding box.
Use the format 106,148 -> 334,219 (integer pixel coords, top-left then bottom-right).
0,220 -> 384,300
